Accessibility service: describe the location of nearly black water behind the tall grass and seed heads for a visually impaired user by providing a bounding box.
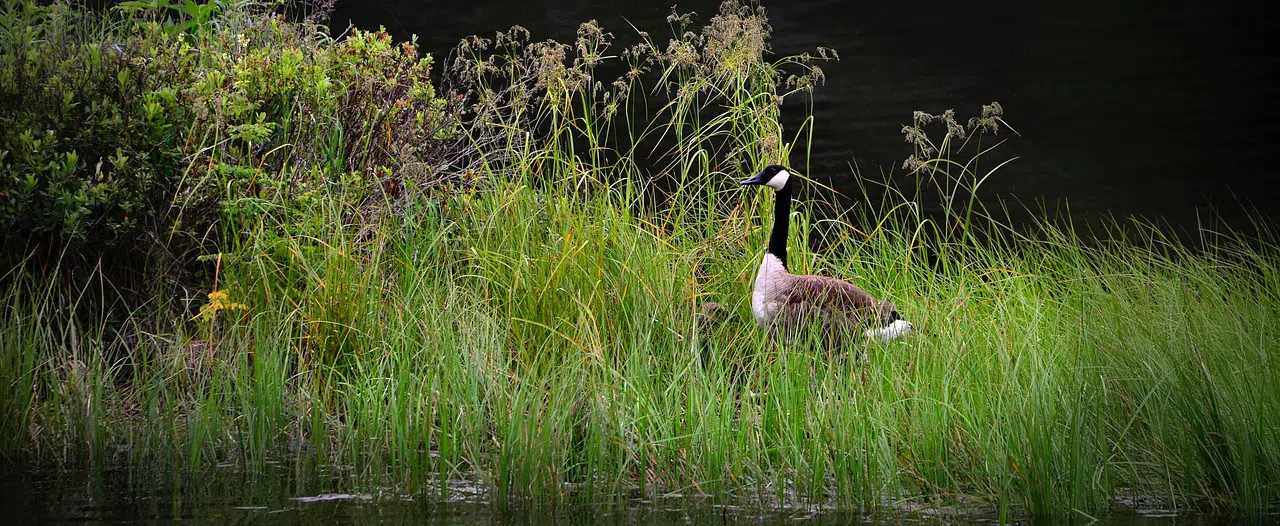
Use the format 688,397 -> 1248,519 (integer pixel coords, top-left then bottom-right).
333,0 -> 1280,234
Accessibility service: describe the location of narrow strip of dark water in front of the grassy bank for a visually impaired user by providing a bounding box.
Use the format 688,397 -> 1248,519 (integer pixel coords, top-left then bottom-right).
0,463 -> 1259,526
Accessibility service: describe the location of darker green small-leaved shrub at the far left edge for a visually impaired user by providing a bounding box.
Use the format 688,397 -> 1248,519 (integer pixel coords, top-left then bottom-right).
0,3 -> 167,246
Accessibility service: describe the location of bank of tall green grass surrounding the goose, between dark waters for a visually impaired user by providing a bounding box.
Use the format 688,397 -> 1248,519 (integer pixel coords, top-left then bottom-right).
0,4 -> 1280,519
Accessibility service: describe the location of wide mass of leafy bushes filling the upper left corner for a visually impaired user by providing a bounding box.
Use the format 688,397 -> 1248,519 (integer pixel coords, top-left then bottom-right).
0,0 -> 454,286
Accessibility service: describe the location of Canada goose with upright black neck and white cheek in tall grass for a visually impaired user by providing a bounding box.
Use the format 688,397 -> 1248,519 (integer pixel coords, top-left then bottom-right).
741,165 -> 911,348
